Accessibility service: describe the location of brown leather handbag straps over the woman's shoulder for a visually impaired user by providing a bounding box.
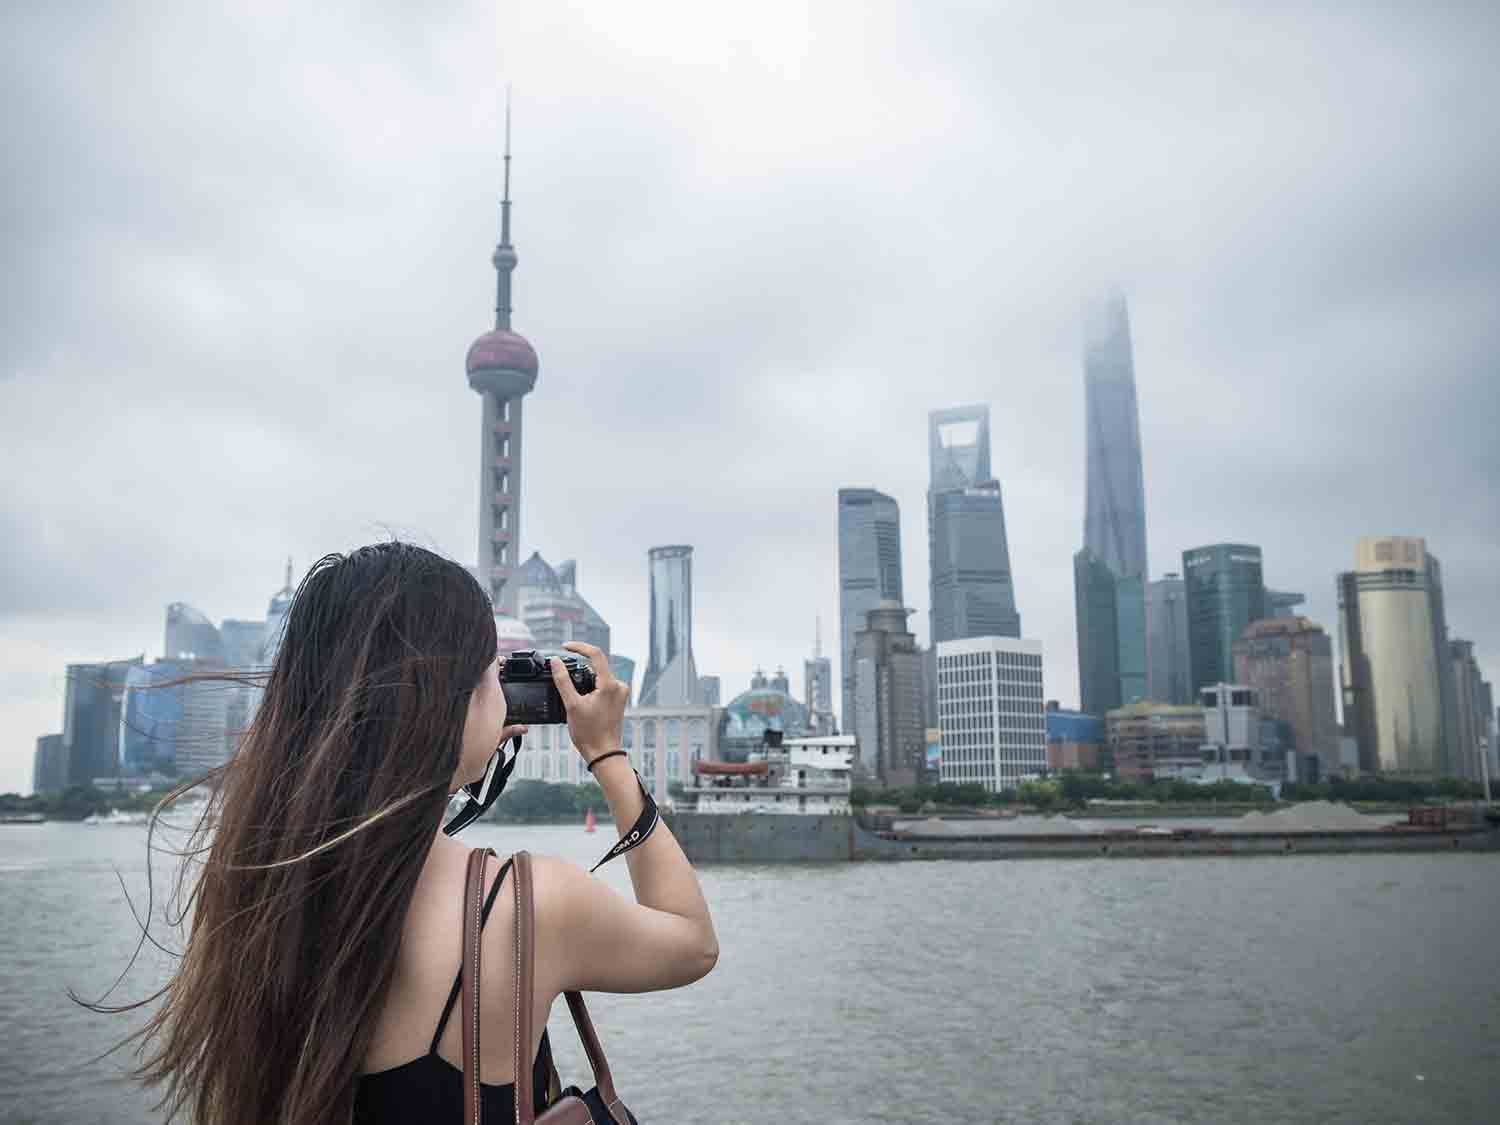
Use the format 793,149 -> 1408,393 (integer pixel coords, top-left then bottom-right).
461,848 -> 639,1125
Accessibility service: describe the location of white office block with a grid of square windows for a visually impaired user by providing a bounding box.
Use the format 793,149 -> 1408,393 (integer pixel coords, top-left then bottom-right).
938,636 -> 1047,794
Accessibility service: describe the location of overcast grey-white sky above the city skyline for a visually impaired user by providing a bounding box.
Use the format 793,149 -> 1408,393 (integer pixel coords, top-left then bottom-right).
0,0 -> 1500,792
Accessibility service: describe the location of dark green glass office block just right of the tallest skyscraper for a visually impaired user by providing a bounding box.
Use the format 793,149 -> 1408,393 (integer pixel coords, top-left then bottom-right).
1182,543 -> 1266,696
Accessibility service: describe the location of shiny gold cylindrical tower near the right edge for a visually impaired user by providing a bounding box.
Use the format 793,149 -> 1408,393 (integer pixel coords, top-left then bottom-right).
1338,536 -> 1457,777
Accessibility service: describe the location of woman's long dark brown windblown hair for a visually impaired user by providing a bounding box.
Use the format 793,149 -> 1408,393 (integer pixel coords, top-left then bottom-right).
96,543 -> 495,1125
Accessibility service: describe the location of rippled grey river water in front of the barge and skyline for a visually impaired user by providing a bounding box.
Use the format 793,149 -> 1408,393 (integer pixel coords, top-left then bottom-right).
0,824 -> 1500,1125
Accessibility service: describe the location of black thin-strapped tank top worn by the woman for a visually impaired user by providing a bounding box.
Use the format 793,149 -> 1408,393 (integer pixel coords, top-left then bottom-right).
354,860 -> 552,1125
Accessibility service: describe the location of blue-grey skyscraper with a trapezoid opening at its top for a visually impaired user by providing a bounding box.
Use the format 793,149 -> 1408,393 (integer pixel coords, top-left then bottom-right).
927,405 -> 1022,644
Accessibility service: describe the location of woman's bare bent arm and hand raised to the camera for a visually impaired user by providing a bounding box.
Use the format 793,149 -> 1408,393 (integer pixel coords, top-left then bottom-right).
536,642 -> 719,992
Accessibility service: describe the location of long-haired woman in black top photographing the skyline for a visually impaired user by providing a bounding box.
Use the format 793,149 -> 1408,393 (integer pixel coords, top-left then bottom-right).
123,543 -> 719,1125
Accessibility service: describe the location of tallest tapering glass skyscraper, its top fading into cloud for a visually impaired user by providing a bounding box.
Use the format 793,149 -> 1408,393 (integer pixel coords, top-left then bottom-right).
1073,290 -> 1146,716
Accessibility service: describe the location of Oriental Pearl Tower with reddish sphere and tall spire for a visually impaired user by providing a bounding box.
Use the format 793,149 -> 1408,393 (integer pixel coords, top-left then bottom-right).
464,98 -> 537,617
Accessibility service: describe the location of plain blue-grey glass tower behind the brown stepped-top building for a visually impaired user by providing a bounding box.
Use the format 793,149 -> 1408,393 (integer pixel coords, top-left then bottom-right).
839,489 -> 903,734
